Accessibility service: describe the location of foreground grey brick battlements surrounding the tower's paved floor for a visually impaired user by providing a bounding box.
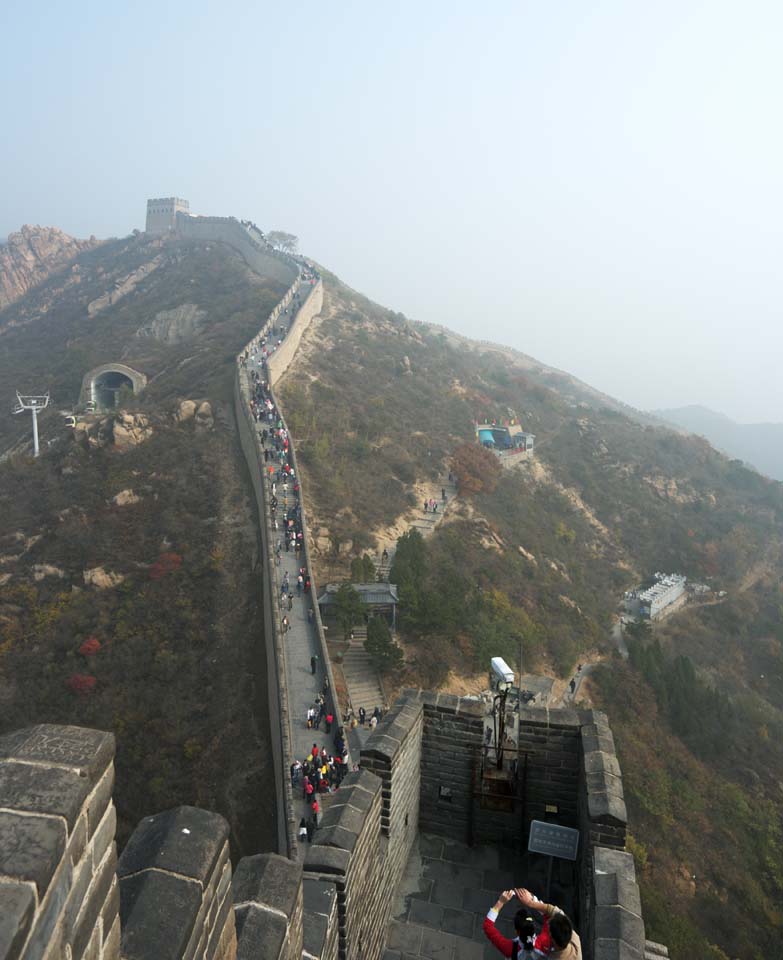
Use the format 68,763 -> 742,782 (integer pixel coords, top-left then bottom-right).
0,690 -> 645,960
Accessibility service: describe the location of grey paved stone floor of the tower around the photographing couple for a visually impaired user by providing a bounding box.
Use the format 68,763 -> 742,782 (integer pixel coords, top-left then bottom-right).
383,834 -> 574,960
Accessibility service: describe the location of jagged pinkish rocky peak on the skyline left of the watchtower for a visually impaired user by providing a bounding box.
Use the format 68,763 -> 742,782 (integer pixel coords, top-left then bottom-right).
0,225 -> 99,310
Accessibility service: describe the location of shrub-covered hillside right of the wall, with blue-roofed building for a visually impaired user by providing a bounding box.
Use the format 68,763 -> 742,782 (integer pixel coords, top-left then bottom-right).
282,277 -> 783,958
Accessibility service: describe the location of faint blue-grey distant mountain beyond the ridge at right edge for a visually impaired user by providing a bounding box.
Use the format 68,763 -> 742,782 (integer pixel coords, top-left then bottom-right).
653,404 -> 783,481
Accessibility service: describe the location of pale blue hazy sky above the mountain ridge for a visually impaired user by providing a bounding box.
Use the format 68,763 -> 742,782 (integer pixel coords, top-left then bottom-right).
0,0 -> 783,420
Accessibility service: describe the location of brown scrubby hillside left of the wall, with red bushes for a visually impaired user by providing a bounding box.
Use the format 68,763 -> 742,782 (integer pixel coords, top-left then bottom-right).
0,237 -> 285,853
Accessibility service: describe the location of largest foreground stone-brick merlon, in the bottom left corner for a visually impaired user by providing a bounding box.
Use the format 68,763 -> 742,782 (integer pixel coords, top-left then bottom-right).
0,724 -> 120,960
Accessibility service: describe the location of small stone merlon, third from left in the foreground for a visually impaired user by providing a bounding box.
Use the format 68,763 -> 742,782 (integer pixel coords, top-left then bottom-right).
232,853 -> 304,960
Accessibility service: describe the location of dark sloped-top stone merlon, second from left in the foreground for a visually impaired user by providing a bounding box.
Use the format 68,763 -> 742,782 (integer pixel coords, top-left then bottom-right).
117,807 -> 236,960
